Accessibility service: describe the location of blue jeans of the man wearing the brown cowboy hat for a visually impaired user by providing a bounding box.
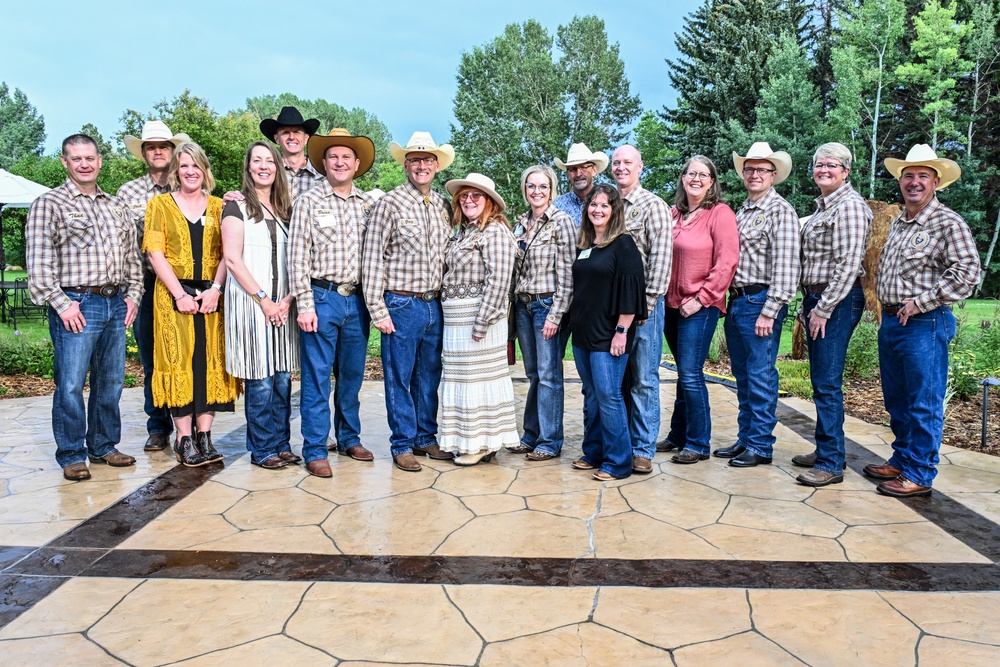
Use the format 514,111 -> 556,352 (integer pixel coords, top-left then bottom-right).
299,286 -> 371,463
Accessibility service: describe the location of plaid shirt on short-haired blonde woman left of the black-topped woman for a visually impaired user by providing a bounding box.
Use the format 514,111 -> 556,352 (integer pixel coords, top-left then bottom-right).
514,206 -> 577,324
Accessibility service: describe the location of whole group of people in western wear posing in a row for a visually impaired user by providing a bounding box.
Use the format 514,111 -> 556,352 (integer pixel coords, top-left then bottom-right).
26,107 -> 980,496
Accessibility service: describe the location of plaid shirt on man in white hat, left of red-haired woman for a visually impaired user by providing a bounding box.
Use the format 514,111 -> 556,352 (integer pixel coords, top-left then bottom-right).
361,181 -> 452,323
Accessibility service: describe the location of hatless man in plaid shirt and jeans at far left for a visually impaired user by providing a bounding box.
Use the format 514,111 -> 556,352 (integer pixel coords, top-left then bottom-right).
25,134 -> 142,481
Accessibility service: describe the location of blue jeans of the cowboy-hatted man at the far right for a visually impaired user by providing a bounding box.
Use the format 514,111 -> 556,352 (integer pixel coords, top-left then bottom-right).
878,308 -> 955,486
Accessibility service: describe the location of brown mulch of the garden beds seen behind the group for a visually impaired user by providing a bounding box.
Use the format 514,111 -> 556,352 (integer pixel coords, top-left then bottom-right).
0,359 -> 1000,456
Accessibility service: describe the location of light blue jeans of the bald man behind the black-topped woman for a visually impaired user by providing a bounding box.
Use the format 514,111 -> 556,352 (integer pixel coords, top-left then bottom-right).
628,296 -> 663,460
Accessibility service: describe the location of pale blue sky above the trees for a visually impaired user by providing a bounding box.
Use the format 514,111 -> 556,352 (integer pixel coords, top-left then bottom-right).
0,0 -> 684,152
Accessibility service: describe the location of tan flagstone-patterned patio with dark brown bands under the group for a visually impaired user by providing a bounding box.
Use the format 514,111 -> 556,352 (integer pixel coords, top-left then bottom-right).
0,364 -> 1000,667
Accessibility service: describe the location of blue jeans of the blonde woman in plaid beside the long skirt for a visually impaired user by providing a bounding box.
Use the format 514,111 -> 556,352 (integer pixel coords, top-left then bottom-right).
514,297 -> 563,454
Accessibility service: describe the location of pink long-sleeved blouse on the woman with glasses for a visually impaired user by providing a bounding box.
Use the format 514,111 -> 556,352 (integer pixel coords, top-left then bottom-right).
667,204 -> 740,313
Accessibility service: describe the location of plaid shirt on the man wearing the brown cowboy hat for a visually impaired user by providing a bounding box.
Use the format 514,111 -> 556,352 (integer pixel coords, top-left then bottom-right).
288,178 -> 372,313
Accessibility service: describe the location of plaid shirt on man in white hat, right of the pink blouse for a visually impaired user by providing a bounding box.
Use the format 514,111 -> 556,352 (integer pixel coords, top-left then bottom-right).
733,188 -> 799,318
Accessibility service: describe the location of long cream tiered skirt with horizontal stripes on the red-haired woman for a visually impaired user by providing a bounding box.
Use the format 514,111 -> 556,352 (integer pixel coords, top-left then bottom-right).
438,297 -> 520,454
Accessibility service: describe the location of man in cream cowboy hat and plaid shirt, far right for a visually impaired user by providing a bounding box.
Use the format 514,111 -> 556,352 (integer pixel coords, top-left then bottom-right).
864,144 -> 981,497
